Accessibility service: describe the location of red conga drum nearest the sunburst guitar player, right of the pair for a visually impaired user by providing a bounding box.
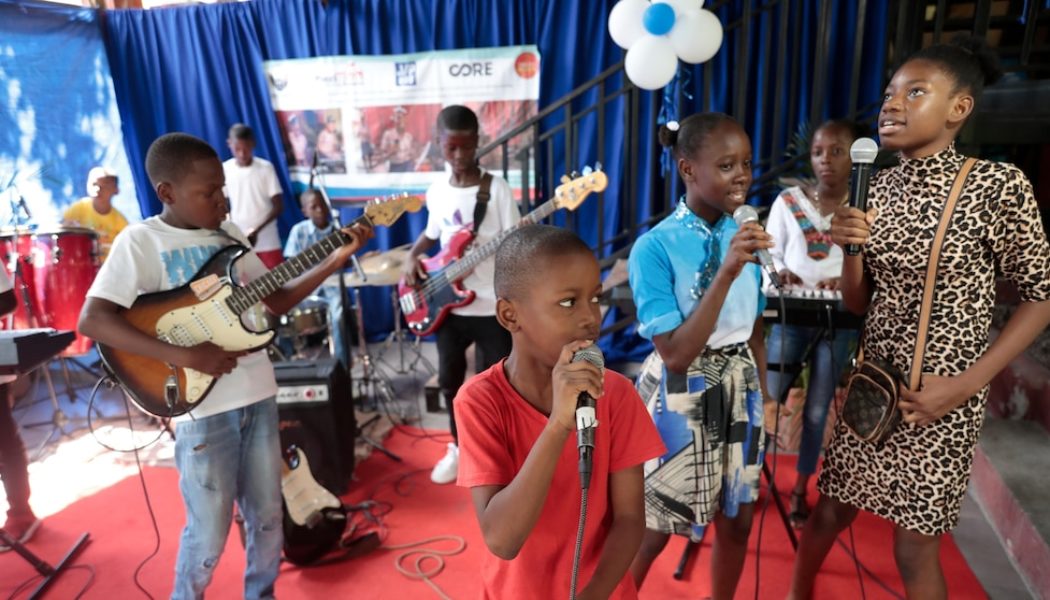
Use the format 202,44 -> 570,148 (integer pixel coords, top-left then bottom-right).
33,227 -> 101,356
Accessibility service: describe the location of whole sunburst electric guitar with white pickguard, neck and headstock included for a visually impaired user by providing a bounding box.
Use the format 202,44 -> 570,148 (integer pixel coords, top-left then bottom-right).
99,194 -> 423,417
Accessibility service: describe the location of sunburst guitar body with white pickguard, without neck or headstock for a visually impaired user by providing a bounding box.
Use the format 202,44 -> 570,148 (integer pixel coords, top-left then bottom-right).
99,246 -> 274,417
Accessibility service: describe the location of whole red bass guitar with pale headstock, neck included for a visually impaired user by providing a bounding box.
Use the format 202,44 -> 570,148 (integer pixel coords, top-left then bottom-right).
397,169 -> 608,335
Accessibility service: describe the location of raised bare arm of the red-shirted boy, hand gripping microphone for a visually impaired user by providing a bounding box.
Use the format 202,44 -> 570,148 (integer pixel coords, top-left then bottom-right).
470,342 -> 603,560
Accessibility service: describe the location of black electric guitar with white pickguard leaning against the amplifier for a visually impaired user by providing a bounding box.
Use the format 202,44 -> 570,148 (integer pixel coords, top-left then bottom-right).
280,446 -> 347,565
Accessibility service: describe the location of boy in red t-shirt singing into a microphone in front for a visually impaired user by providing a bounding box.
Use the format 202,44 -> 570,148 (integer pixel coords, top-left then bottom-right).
456,225 -> 666,599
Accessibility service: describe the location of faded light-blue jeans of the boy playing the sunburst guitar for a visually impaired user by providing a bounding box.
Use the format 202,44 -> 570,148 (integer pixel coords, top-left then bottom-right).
171,398 -> 284,599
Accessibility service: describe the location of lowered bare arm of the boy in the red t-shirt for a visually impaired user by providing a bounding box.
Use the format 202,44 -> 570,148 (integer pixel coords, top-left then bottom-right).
578,464 -> 646,599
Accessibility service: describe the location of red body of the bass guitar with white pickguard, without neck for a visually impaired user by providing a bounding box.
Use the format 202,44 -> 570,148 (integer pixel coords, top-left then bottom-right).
397,228 -> 476,335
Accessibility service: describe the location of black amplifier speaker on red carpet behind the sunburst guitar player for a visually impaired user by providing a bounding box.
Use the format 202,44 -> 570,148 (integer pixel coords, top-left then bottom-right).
273,358 -> 357,494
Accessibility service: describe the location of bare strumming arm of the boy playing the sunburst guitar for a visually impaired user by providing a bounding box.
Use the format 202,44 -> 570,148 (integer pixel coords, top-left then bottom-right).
77,297 -> 246,377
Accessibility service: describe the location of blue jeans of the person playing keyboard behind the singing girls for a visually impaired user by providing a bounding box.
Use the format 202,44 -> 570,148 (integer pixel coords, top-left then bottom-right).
765,325 -> 857,475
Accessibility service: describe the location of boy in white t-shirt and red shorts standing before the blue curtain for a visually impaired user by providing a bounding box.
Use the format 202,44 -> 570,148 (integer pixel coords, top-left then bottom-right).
223,123 -> 284,269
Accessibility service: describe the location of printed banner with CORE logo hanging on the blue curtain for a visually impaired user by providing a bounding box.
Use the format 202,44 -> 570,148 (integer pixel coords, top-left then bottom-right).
264,45 -> 540,200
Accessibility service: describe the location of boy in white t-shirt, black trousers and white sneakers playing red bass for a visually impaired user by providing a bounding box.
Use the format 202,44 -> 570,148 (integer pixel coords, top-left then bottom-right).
403,105 -> 521,483
